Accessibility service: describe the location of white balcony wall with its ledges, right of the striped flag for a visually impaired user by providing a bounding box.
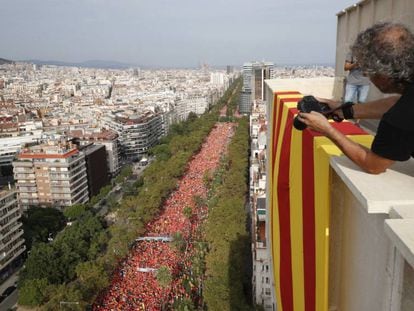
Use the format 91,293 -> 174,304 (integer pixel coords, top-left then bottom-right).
329,157 -> 414,311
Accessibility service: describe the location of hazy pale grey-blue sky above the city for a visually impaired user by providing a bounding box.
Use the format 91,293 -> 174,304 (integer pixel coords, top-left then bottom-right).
0,0 -> 357,67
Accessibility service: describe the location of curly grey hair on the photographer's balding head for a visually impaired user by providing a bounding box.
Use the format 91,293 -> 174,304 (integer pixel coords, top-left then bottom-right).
351,23 -> 414,84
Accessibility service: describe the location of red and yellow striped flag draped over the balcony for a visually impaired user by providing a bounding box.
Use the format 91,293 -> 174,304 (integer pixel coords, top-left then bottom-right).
268,91 -> 372,311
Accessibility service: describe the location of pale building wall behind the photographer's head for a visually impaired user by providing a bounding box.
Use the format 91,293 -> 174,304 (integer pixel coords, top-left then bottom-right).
334,0 -> 414,99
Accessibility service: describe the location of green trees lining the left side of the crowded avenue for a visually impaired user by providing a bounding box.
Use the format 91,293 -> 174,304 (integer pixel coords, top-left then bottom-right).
19,76 -> 240,310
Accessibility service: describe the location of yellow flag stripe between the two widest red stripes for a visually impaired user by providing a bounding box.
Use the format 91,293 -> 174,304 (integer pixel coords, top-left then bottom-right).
289,112 -> 305,310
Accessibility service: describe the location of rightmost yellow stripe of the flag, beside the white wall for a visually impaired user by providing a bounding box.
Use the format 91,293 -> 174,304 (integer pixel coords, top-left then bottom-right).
314,135 -> 372,311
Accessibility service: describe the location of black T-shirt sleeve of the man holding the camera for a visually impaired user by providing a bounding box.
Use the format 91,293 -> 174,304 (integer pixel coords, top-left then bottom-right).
371,120 -> 414,161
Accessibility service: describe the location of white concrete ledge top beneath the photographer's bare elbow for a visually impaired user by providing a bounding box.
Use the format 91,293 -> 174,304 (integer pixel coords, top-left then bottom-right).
330,156 -> 414,214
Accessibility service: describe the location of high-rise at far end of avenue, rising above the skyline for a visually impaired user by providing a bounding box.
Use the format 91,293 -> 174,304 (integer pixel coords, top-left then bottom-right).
239,62 -> 273,114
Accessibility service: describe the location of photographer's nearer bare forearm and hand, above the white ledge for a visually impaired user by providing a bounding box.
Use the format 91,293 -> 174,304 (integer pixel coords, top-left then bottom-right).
299,111 -> 394,174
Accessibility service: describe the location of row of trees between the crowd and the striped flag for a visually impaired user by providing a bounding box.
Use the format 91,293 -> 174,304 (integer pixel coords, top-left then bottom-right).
203,118 -> 251,310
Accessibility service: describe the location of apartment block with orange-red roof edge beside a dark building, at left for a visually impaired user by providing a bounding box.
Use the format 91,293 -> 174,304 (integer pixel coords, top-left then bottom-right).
13,142 -> 89,209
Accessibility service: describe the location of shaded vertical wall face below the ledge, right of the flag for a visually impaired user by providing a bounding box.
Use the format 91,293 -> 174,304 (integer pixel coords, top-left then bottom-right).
329,172 -> 391,311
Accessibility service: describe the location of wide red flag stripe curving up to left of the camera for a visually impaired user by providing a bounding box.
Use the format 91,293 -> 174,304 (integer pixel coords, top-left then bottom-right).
277,106 -> 293,311
